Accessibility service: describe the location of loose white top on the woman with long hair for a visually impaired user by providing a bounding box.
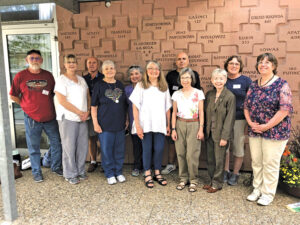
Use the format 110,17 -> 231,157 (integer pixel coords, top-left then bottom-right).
129,83 -> 172,134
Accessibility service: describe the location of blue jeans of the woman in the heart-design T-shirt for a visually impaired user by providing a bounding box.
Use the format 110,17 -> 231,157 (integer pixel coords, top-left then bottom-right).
98,130 -> 125,178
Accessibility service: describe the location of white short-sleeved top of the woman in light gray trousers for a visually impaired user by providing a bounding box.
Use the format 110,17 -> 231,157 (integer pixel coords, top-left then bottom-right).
54,74 -> 88,122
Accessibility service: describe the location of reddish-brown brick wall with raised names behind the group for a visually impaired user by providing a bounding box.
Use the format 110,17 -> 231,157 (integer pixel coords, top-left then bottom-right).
57,0 -> 300,169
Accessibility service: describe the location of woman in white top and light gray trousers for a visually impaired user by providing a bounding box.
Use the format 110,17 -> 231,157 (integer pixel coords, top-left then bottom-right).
54,54 -> 90,184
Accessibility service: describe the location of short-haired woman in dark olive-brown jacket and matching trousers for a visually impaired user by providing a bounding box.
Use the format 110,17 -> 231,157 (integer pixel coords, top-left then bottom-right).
203,68 -> 235,193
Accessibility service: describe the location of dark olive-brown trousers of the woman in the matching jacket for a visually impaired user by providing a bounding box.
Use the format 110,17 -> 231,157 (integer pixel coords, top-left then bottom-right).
206,136 -> 228,189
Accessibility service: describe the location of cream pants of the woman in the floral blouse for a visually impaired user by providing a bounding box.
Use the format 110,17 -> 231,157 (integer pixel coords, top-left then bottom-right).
249,137 -> 288,199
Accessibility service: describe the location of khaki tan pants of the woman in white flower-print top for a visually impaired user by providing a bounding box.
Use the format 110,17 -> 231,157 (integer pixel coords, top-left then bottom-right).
175,120 -> 201,184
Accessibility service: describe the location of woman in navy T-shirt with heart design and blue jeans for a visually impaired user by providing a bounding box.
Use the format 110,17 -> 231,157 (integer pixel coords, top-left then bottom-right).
91,60 -> 127,185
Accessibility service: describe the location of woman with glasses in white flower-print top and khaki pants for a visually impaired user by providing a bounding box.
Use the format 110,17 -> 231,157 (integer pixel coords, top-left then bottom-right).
172,68 -> 205,192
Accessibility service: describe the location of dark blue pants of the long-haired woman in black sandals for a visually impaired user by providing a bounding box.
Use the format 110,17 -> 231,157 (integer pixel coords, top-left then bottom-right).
142,132 -> 165,171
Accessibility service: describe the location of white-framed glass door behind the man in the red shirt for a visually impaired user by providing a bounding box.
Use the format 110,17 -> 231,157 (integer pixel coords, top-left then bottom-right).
3,25 -> 58,149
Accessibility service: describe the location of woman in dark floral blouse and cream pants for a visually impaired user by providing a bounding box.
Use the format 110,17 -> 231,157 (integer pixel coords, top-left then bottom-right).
244,53 -> 293,205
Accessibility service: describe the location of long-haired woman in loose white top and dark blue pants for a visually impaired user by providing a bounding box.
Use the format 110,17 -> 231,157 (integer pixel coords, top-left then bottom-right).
129,61 -> 171,188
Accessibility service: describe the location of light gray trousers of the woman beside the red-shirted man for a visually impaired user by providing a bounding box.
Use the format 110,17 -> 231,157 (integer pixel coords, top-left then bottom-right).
58,118 -> 89,178
